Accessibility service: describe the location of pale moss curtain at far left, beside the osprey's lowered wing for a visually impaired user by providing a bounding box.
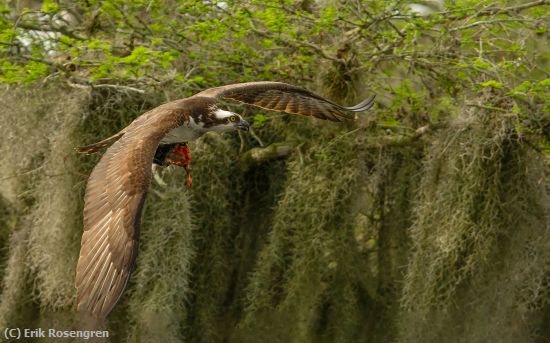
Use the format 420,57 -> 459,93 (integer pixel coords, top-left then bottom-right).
0,88 -> 86,325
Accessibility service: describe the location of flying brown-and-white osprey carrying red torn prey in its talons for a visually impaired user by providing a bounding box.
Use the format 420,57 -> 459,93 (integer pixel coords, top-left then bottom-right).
75,82 -> 374,317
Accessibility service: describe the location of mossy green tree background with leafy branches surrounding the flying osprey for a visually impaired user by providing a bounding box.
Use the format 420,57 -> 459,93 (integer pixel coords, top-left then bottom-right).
0,0 -> 550,343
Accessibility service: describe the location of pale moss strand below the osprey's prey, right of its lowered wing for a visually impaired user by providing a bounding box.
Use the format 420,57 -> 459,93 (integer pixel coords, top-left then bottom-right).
121,169 -> 194,342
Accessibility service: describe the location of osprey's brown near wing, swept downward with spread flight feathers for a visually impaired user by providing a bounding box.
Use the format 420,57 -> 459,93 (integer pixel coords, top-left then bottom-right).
75,104 -> 186,317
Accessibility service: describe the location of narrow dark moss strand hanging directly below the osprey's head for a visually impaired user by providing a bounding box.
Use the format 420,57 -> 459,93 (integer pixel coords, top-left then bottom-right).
183,134 -> 244,342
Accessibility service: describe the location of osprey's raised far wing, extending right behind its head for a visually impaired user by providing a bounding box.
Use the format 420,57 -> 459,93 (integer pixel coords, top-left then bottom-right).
197,81 -> 374,121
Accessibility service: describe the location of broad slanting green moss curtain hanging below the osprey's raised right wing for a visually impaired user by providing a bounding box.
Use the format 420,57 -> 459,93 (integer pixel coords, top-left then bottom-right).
237,134 -> 374,341
